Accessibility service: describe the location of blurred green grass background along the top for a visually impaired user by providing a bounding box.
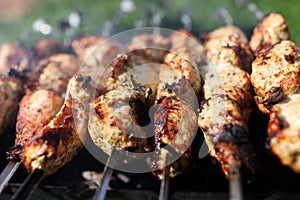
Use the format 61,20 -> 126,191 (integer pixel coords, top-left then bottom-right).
0,0 -> 300,45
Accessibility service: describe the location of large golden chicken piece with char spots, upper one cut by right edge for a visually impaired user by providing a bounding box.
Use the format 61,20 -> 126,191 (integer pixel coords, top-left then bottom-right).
251,40 -> 300,113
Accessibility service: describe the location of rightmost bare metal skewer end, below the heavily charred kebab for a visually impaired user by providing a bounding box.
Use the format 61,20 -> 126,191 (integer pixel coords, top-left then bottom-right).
229,166 -> 243,200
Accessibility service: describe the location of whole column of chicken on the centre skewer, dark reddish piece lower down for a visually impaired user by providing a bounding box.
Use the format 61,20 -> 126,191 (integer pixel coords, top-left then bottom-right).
152,31 -> 204,179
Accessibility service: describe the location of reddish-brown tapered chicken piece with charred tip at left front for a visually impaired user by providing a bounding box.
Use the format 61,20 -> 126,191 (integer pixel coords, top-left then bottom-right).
8,90 -> 63,160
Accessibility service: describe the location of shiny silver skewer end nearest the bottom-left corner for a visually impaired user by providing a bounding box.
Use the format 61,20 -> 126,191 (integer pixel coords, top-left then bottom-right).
0,161 -> 21,194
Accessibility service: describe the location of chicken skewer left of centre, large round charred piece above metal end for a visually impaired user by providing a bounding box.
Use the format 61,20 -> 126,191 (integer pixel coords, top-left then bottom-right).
89,35 -> 165,199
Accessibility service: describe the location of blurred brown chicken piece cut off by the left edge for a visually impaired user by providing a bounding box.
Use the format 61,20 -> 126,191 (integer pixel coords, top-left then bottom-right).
0,77 -> 23,135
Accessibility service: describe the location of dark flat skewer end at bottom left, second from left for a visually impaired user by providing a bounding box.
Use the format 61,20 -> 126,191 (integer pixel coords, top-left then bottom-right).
11,169 -> 45,200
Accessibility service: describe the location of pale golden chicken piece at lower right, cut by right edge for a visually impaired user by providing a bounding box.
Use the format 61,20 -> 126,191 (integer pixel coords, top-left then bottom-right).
268,93 -> 300,174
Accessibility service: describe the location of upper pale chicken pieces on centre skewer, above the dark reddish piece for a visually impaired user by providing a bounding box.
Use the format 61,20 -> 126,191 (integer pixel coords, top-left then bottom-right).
156,31 -> 205,103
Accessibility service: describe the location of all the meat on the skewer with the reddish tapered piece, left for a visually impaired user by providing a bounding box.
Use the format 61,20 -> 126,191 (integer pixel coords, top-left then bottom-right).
8,54 -> 78,163
